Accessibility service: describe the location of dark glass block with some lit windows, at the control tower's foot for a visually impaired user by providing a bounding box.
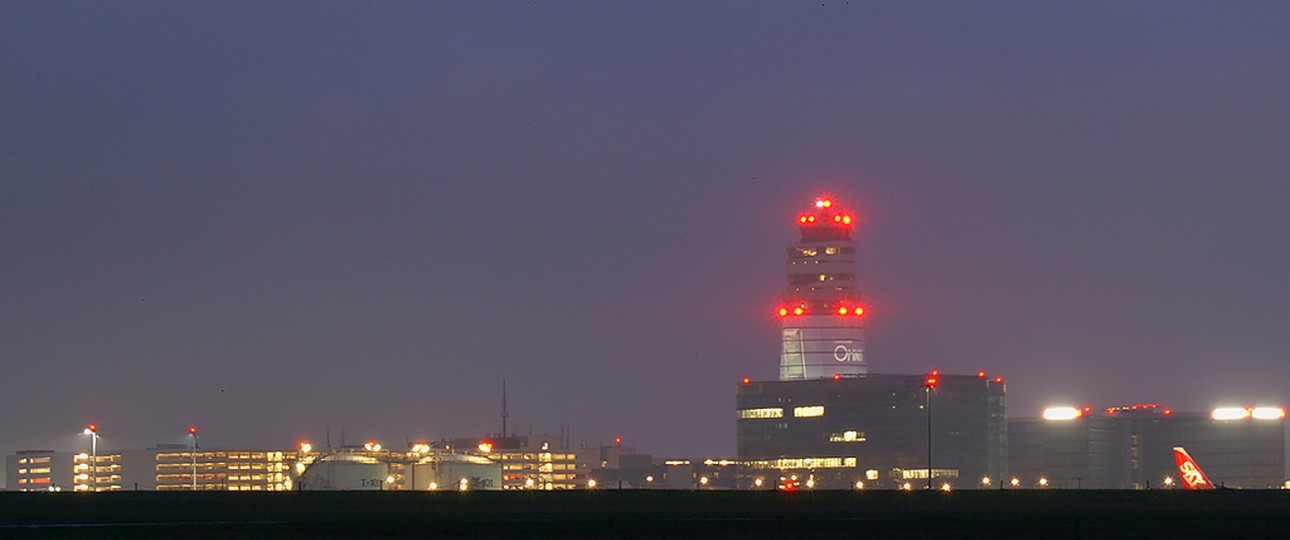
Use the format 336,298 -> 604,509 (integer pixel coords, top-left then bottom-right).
737,375 -> 1007,488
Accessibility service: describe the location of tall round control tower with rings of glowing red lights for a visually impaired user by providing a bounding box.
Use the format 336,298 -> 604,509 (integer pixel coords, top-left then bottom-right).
775,197 -> 868,380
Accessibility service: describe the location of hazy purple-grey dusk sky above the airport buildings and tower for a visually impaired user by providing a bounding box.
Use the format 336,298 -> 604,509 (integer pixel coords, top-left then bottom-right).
0,0 -> 1290,482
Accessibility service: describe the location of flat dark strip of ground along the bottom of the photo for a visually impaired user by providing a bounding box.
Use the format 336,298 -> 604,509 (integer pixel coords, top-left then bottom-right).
0,490 -> 1290,539
